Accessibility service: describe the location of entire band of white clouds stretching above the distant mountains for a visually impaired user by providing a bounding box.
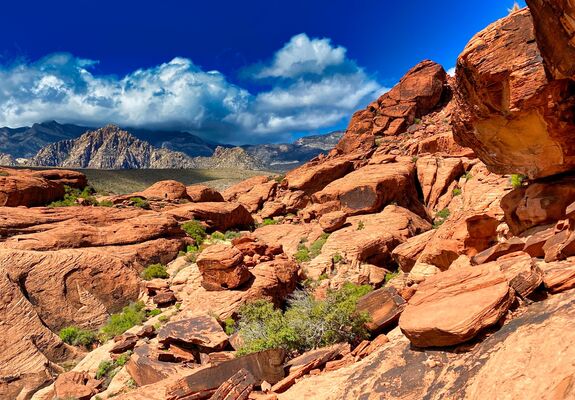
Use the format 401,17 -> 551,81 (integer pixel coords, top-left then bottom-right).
0,34 -> 385,143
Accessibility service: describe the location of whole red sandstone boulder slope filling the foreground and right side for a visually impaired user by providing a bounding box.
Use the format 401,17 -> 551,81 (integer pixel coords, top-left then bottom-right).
0,0 -> 575,400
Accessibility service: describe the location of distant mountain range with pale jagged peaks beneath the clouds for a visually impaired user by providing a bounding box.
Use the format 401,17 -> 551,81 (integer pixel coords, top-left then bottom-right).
0,121 -> 343,171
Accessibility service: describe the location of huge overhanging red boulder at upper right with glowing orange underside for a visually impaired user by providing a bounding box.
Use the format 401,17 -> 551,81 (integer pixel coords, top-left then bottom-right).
454,9 -> 575,178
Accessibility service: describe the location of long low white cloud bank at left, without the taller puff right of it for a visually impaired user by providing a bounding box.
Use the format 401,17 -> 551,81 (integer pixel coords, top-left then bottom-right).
0,54 -> 250,130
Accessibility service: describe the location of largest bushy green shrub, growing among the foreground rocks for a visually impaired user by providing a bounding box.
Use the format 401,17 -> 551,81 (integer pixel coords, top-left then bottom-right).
237,283 -> 371,354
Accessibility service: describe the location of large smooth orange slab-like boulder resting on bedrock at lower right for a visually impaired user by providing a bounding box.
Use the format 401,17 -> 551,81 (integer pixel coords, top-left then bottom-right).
399,265 -> 513,347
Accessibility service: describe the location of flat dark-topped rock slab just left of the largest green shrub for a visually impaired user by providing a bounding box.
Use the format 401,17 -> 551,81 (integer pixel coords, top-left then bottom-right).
158,315 -> 228,351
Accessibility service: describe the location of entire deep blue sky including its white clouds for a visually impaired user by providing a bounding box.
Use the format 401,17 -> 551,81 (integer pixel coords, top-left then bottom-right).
0,0 -> 524,144
